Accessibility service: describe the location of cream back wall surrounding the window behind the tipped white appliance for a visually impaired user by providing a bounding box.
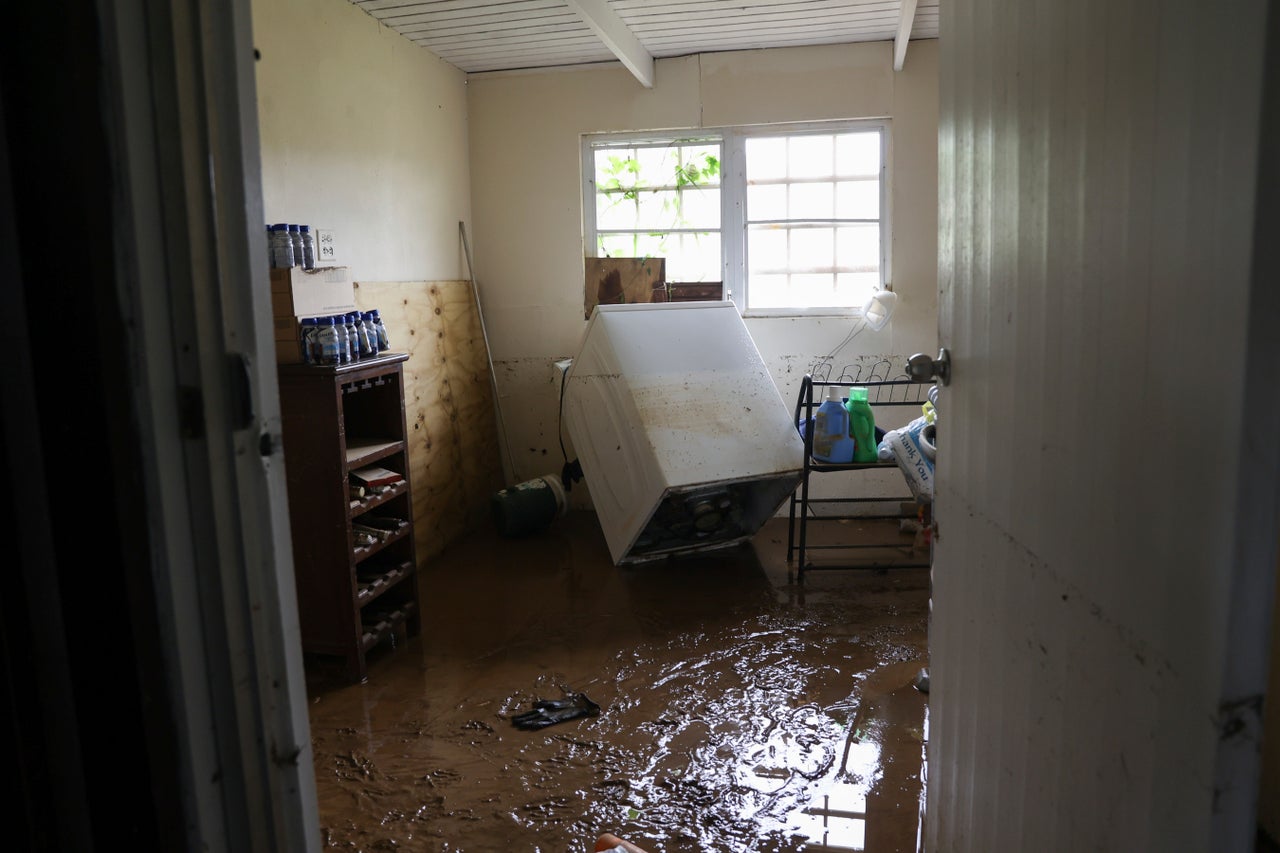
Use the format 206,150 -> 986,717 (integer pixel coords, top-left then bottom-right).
467,40 -> 937,497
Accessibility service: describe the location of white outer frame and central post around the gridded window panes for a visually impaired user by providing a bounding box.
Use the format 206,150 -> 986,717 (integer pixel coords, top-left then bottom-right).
581,119 -> 893,318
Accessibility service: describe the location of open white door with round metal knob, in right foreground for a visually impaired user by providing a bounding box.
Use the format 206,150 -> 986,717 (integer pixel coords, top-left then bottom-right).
925,0 -> 1280,853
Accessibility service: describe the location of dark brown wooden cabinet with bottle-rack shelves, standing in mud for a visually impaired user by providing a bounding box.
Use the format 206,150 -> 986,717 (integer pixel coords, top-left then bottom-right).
278,352 -> 420,681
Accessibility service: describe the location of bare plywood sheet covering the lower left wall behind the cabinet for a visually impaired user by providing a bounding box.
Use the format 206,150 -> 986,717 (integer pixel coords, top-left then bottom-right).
356,282 -> 503,566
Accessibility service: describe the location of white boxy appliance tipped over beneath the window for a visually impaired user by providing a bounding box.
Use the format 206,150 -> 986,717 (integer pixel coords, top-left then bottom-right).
563,302 -> 804,566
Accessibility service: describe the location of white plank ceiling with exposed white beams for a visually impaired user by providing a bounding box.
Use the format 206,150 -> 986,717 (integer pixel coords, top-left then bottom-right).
352,0 -> 938,85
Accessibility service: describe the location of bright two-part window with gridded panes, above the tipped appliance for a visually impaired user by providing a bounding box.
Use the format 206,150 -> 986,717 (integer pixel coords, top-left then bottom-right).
582,122 -> 890,315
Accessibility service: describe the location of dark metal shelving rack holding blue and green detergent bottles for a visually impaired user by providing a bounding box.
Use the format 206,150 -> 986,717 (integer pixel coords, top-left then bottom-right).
787,374 -> 933,583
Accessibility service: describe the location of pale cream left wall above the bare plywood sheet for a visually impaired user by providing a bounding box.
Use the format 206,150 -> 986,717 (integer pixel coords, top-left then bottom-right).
252,0 -> 471,280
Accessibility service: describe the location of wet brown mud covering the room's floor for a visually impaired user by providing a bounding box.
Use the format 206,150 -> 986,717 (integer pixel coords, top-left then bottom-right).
308,512 -> 929,853
